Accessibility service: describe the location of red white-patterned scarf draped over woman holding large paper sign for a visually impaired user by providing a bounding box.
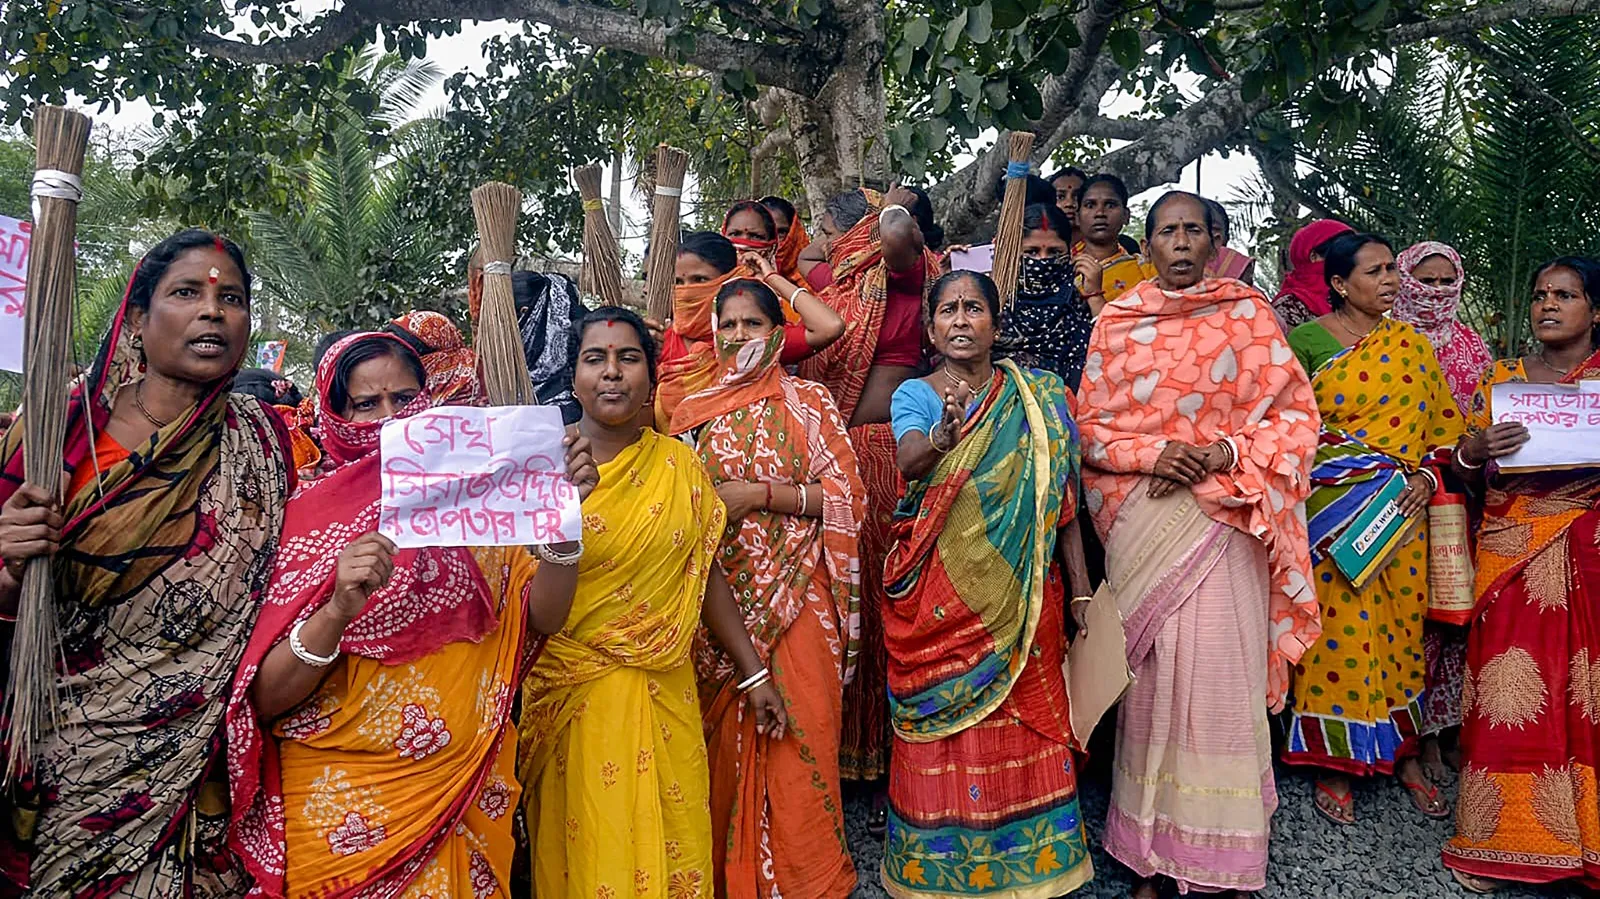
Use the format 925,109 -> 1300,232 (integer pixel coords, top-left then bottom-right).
227,333 -> 499,896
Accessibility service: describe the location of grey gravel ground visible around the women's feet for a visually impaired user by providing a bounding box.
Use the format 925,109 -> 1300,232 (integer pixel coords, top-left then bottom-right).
845,739 -> 1582,899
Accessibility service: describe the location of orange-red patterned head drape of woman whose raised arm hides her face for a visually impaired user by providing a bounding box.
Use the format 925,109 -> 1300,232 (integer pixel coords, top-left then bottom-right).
800,187 -> 939,421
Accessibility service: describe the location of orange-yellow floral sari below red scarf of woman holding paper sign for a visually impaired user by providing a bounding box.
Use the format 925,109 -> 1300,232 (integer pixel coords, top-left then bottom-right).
272,547 -> 536,899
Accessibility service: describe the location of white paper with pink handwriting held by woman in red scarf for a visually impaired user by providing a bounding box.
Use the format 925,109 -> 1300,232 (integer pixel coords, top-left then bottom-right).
378,406 -> 582,547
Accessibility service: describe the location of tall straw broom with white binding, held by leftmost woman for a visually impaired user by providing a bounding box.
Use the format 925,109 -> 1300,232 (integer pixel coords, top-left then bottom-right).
5,106 -> 90,784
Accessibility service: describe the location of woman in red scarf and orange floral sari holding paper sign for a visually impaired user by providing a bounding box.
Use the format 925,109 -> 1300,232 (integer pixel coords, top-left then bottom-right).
229,333 -> 598,897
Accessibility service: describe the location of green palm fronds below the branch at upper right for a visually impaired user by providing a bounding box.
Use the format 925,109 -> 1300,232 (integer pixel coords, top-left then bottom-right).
1280,26 -> 1600,352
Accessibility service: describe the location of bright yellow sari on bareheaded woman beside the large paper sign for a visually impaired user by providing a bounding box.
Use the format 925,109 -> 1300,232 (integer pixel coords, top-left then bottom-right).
518,430 -> 726,899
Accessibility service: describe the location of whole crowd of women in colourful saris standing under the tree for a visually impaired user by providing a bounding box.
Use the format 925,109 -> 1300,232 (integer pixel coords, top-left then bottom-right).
0,170 -> 1600,899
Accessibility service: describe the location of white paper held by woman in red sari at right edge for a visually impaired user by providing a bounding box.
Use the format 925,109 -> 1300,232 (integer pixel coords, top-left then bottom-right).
1490,381 -> 1600,472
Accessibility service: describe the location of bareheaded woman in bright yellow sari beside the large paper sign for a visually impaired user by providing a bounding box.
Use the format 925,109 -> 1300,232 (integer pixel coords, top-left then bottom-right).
517,307 -> 784,899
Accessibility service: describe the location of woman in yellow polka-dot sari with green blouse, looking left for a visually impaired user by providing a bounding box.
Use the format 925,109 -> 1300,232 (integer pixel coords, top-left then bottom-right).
1283,234 -> 1462,824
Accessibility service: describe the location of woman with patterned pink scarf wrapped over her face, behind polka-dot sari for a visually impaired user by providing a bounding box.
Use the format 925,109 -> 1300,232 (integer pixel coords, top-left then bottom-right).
1394,240 -> 1494,779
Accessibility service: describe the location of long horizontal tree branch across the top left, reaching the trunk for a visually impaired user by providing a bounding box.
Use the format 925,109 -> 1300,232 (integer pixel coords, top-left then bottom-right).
192,0 -> 835,96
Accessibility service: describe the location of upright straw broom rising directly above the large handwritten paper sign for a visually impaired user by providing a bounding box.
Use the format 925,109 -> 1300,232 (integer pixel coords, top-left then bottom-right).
472,181 -> 536,406
